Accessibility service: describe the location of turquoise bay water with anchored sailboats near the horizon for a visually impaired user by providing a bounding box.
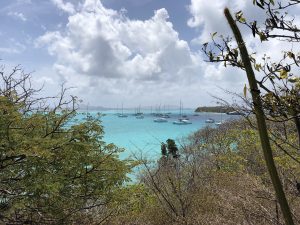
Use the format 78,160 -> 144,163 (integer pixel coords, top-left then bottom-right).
74,109 -> 236,158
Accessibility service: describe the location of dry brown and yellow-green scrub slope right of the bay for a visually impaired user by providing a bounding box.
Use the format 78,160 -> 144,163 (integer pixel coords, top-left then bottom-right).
107,119 -> 300,225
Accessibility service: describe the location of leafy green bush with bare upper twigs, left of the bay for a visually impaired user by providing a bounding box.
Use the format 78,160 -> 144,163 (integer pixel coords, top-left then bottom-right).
0,67 -> 131,224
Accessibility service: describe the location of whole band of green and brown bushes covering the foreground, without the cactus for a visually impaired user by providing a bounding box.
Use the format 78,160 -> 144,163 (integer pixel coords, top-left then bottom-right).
4,68 -> 300,225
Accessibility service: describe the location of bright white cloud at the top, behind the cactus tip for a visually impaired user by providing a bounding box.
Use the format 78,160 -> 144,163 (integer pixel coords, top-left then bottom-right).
187,0 -> 300,49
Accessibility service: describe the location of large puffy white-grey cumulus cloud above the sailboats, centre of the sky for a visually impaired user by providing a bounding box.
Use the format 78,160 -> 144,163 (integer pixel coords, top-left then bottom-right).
36,0 -> 209,105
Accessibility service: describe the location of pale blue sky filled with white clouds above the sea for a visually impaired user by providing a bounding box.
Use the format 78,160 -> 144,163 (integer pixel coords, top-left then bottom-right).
0,0 -> 298,107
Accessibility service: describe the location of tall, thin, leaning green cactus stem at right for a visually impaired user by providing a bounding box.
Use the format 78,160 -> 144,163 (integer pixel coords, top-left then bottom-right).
224,8 -> 294,225
